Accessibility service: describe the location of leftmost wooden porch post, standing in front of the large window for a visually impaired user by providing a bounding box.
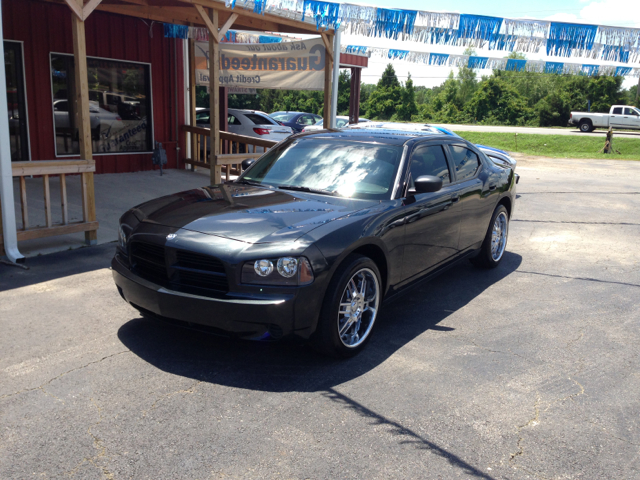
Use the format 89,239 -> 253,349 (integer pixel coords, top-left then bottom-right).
71,6 -> 98,245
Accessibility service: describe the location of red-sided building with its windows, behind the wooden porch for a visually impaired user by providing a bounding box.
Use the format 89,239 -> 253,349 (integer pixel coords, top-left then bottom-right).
2,0 -> 185,173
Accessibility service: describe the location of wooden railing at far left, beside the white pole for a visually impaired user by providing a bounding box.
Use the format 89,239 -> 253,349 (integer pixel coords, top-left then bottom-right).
0,160 -> 98,252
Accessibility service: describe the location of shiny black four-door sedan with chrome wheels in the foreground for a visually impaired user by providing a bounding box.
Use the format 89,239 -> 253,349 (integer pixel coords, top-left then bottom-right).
112,129 -> 516,356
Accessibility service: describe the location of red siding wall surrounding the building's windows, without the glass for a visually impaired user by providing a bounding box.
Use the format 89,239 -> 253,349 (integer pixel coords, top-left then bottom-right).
2,0 -> 185,173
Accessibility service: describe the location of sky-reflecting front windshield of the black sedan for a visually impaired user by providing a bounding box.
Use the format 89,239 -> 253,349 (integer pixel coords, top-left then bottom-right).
239,137 -> 402,200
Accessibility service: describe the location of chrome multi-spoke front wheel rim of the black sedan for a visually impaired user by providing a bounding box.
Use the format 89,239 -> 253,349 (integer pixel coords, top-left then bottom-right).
338,268 -> 380,348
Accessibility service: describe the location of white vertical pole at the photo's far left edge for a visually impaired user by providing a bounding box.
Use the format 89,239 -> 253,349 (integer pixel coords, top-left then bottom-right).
0,0 -> 24,263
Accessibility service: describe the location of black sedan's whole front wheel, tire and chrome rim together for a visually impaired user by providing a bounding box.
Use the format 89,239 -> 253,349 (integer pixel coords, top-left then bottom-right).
311,254 -> 382,358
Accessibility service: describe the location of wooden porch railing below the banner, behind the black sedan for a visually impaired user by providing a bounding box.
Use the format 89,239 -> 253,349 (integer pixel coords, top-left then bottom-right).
182,125 -> 278,180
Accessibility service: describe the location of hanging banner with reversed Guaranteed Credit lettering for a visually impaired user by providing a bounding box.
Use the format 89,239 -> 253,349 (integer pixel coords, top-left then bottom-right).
196,38 -> 326,90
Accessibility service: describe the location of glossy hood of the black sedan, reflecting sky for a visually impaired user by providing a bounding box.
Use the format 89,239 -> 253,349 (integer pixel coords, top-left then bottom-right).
132,184 -> 378,243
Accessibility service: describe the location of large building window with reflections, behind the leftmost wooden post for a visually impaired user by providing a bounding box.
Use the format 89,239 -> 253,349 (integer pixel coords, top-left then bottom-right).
51,53 -> 153,156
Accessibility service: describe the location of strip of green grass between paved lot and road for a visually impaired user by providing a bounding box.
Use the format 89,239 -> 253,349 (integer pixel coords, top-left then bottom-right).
456,132 -> 640,160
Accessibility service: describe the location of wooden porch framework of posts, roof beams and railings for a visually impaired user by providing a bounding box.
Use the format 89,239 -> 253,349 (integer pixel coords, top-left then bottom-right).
0,0 -> 335,253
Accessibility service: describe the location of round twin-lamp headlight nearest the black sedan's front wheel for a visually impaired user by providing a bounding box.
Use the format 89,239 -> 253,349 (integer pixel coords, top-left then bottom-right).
241,257 -> 314,286
